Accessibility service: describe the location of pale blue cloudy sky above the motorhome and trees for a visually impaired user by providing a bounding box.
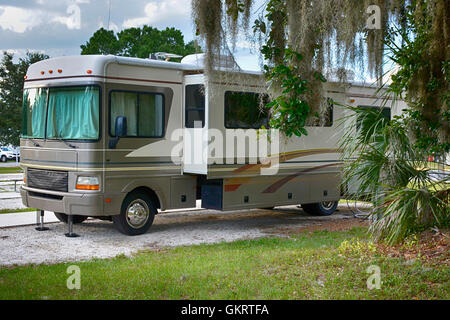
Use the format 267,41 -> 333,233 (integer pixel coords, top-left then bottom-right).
0,0 -> 263,70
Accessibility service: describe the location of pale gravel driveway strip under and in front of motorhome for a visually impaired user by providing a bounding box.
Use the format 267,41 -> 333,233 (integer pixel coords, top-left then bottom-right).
0,206 -> 353,266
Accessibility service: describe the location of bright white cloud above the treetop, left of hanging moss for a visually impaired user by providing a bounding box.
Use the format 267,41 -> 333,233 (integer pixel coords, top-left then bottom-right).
123,0 -> 191,28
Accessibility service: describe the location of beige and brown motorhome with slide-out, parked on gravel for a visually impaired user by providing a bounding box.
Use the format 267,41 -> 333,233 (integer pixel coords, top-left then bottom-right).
21,55 -> 402,235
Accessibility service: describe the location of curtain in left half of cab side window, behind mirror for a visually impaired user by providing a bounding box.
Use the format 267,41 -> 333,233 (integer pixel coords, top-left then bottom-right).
110,92 -> 138,137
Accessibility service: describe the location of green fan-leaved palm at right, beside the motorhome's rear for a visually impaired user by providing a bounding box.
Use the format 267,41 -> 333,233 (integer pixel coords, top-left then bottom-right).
340,107 -> 450,244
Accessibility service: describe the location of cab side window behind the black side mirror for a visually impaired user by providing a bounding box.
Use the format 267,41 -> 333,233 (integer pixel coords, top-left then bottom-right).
109,91 -> 165,138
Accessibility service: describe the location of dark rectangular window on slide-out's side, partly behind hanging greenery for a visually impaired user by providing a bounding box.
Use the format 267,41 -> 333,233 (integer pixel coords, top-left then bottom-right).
225,91 -> 269,129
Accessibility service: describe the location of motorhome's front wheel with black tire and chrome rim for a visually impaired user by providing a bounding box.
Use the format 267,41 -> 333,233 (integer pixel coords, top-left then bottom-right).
112,191 -> 156,236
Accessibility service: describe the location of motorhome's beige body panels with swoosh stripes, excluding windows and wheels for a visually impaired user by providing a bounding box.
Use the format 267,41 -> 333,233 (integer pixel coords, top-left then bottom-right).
21,56 -> 406,221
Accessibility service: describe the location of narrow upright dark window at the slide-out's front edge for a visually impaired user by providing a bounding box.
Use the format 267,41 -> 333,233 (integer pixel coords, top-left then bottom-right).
185,84 -> 205,128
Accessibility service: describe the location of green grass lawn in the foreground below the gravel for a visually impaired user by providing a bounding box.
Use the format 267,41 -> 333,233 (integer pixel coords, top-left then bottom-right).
0,228 -> 450,299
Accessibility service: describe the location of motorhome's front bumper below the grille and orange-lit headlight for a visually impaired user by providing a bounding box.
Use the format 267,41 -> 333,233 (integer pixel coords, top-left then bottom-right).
20,186 -> 104,217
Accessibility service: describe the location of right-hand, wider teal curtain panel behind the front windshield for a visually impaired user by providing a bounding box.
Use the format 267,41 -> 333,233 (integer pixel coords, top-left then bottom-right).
47,87 -> 100,140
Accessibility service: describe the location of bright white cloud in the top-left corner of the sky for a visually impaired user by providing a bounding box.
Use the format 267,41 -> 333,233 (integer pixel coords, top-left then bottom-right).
0,6 -> 43,33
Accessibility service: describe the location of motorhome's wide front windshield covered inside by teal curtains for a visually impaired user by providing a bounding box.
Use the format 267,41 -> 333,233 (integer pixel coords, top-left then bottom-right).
22,86 -> 100,140
